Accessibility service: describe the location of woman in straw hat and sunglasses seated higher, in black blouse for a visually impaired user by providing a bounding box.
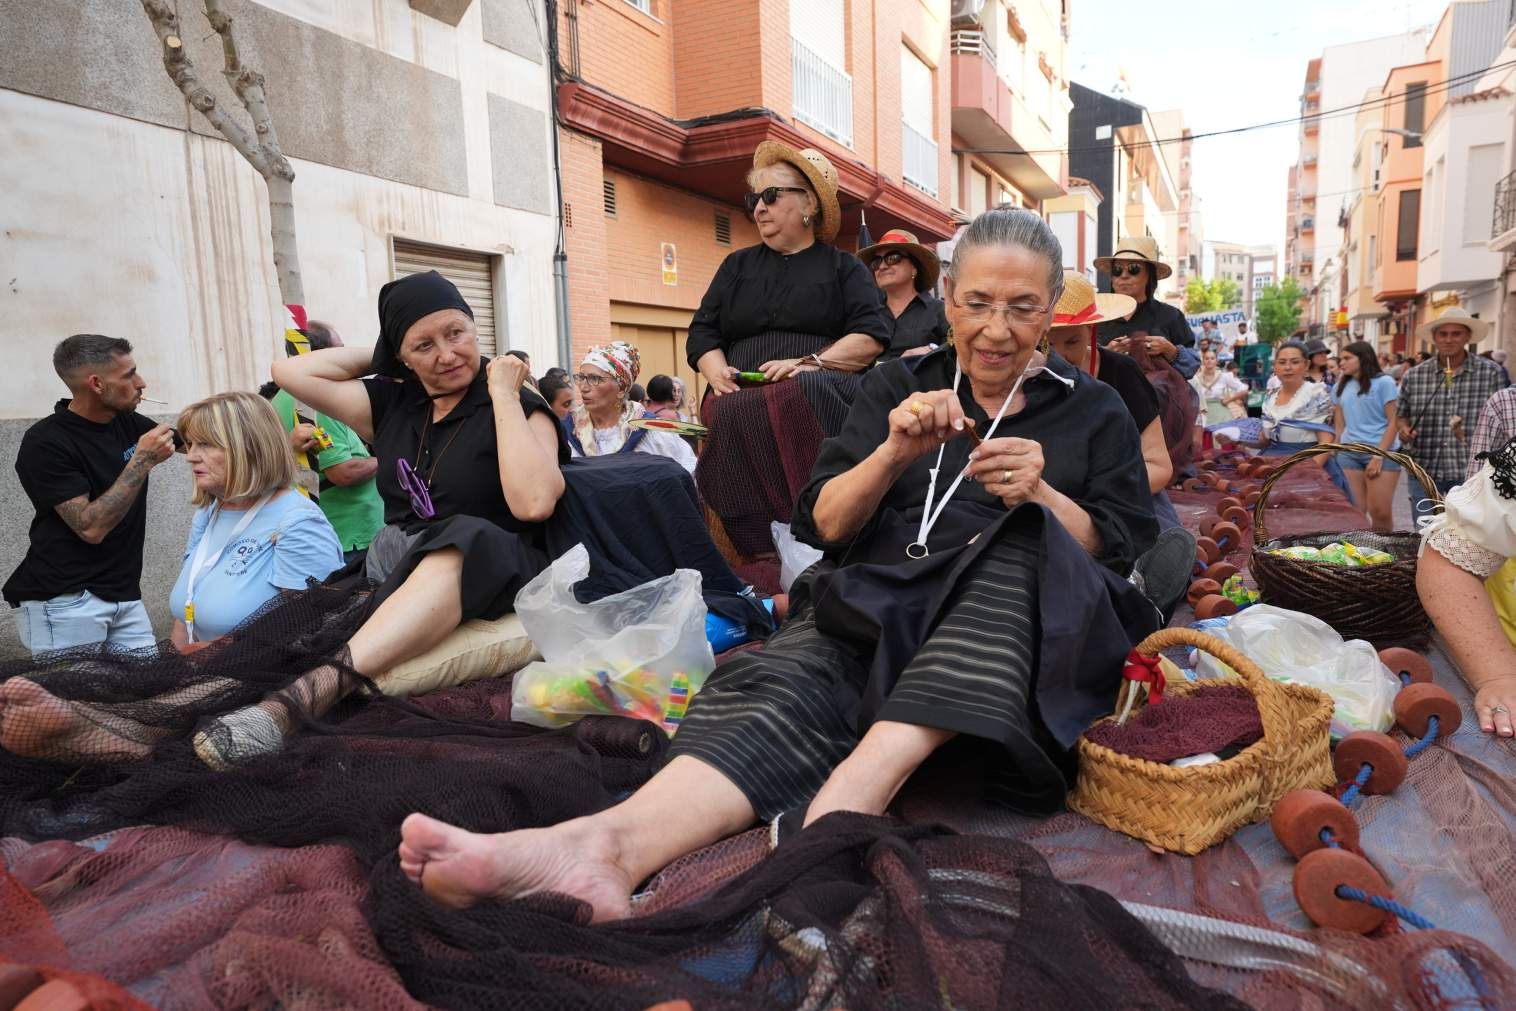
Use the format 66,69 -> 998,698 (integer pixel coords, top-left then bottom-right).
685,141 -> 890,555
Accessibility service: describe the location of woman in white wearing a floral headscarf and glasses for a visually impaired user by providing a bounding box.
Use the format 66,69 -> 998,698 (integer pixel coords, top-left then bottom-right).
564,341 -> 694,474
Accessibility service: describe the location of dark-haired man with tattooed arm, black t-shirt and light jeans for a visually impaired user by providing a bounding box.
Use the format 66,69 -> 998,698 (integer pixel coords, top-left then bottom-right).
5,333 -> 174,655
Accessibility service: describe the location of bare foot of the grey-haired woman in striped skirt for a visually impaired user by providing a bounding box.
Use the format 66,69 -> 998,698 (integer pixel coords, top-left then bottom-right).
400,814 -> 637,922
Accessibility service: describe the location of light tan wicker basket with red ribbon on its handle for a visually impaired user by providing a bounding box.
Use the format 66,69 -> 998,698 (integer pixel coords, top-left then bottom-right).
1069,629 -> 1336,855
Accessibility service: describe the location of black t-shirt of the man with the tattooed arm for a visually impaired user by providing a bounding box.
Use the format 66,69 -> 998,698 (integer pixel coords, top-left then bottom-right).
5,400 -> 158,608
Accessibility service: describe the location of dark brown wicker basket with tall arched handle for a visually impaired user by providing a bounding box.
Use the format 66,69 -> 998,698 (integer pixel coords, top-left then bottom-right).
1248,443 -> 1442,649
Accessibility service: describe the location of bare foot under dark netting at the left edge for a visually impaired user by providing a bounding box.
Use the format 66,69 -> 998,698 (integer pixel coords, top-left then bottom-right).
0,678 -> 168,761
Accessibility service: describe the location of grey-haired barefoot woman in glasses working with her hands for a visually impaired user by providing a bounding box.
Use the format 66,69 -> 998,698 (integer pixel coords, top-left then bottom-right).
400,209 -> 1158,920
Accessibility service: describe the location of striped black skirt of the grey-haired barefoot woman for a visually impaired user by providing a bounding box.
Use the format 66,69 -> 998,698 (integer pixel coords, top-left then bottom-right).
670,523 -> 1073,819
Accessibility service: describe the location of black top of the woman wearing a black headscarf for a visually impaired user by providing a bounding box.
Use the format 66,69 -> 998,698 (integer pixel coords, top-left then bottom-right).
364,364 -> 570,538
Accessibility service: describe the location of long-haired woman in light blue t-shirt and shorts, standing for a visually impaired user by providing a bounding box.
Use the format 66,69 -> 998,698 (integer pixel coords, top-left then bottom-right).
1331,341 -> 1401,531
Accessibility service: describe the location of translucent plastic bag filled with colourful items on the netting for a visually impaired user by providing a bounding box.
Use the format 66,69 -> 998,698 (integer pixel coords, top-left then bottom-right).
511,544 -> 716,734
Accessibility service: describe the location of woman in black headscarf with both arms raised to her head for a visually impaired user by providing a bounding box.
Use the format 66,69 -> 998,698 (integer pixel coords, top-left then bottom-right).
0,271 -> 569,767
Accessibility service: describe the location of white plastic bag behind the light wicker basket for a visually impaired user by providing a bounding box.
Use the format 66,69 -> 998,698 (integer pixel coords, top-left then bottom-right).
1196,603 -> 1401,738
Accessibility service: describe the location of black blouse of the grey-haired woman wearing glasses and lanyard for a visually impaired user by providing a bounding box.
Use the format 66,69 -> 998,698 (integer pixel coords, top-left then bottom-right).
791,347 -> 1158,576
